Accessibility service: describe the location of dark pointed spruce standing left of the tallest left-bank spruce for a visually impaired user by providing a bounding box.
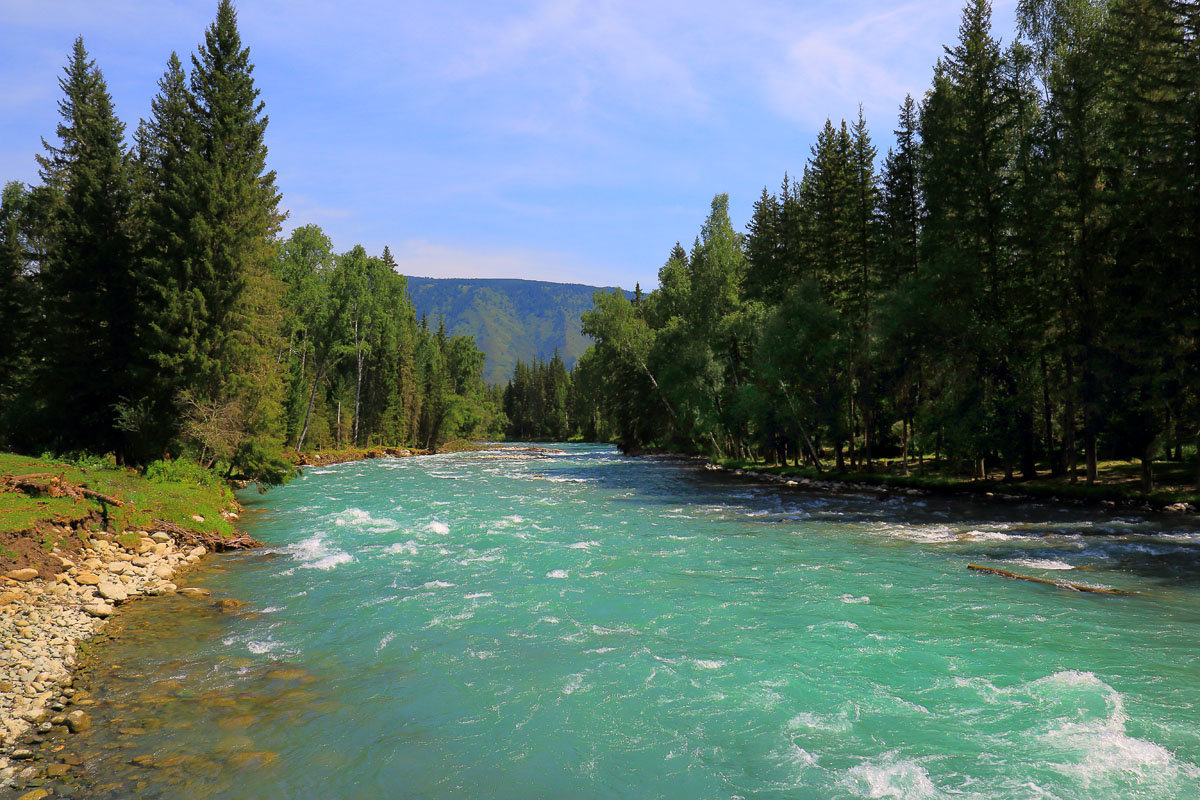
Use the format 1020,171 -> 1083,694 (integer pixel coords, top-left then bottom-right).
37,38 -> 140,455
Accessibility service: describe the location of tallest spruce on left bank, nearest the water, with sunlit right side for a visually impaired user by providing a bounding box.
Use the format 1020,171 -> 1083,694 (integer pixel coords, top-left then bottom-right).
181,0 -> 290,480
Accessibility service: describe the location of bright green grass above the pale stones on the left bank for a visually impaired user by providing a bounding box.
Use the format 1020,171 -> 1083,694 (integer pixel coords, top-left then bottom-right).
0,453 -> 235,536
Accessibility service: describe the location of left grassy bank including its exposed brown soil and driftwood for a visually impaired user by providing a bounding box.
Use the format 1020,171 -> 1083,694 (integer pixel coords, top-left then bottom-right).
0,453 -> 238,575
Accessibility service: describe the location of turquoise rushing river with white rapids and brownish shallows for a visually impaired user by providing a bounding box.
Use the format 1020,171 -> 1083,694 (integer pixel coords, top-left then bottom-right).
32,446 -> 1200,800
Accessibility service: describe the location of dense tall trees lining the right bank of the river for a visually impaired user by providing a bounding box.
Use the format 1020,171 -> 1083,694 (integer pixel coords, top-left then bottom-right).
572,0 -> 1200,491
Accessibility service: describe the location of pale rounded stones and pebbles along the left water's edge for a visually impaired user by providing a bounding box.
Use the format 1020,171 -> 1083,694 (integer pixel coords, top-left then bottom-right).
0,531 -> 206,794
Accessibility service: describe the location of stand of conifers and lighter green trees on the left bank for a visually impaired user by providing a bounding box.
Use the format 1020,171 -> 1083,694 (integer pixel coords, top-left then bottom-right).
0,0 -> 503,485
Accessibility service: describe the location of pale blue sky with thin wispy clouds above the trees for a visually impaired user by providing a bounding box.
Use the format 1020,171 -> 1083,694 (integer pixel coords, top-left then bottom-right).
0,0 -> 1015,288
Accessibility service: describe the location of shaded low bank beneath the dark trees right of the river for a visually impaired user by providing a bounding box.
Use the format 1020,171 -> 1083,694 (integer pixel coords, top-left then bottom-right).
714,458 -> 1200,509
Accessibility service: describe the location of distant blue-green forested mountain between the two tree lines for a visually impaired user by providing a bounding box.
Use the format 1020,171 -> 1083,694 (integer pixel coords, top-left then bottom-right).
408,276 -> 632,384
